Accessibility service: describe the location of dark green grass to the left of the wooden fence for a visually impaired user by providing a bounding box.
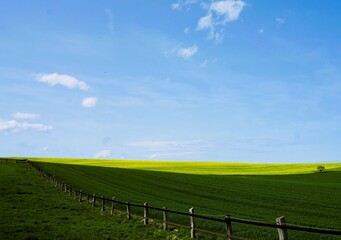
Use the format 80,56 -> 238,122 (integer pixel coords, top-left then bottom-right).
0,161 -> 187,240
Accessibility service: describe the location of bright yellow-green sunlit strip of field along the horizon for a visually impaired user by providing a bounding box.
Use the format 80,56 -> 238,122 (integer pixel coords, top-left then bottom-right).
24,158 -> 341,175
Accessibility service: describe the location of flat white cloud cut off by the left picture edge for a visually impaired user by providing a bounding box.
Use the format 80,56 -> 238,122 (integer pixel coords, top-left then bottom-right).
0,120 -> 53,132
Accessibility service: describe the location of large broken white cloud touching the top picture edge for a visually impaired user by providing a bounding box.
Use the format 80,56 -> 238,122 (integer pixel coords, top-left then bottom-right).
197,0 -> 246,43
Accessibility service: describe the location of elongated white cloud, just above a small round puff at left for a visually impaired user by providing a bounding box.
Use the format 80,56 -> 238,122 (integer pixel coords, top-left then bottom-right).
35,73 -> 89,91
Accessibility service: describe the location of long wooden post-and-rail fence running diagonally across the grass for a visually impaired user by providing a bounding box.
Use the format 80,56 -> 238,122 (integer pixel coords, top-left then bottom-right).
21,159 -> 341,240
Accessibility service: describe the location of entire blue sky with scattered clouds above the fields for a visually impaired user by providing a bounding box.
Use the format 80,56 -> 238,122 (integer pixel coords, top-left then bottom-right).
0,0 -> 341,163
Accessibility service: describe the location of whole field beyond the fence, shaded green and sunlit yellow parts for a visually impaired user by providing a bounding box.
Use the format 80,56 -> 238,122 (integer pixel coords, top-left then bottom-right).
19,159 -> 341,239
